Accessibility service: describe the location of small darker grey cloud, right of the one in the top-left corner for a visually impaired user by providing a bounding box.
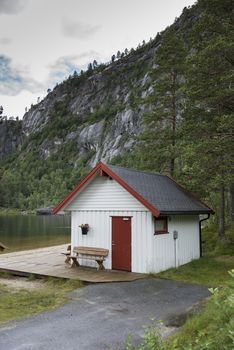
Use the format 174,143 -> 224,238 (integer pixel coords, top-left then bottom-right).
62,18 -> 101,40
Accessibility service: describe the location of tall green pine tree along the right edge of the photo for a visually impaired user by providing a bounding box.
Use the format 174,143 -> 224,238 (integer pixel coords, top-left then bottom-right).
183,0 -> 234,238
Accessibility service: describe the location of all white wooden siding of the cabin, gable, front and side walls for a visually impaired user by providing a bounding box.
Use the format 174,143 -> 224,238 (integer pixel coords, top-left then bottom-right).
66,177 -> 200,273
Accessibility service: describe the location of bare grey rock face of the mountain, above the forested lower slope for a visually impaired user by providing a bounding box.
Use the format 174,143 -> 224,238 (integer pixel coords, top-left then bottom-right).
0,39 -> 158,166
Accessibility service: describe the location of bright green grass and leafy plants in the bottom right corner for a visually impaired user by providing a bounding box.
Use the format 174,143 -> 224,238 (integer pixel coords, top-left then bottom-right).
126,270 -> 234,350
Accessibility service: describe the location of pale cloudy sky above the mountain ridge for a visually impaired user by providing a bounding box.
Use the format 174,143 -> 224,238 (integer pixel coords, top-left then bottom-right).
0,0 -> 195,118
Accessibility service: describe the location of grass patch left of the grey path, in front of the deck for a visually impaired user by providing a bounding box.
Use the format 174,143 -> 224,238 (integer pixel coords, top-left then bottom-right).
0,278 -> 81,323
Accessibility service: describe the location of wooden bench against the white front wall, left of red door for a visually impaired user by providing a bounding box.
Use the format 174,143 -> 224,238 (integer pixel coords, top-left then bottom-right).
66,247 -> 109,270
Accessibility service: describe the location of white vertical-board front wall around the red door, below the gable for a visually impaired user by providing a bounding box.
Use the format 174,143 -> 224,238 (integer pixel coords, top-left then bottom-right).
72,210 -> 152,272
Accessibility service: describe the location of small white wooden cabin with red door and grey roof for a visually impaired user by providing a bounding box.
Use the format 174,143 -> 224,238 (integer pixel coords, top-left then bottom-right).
54,162 -> 213,273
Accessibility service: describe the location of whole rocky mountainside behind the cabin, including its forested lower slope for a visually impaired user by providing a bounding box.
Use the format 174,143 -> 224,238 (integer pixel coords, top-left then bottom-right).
0,2 -> 204,209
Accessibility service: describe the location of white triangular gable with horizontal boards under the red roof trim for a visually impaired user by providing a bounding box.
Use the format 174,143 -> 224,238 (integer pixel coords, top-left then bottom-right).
65,176 -> 147,211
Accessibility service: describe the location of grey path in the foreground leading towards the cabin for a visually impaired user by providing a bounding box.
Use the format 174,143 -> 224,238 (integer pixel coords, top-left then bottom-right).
0,279 -> 209,350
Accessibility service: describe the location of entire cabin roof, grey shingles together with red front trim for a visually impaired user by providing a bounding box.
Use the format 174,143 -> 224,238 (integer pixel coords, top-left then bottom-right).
53,162 -> 213,217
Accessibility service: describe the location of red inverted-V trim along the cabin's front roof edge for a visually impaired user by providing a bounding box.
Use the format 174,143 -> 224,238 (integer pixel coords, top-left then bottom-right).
53,162 -> 160,217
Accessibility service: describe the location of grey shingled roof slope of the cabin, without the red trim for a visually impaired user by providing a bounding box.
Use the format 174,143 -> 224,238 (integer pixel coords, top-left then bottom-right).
107,164 -> 213,215
